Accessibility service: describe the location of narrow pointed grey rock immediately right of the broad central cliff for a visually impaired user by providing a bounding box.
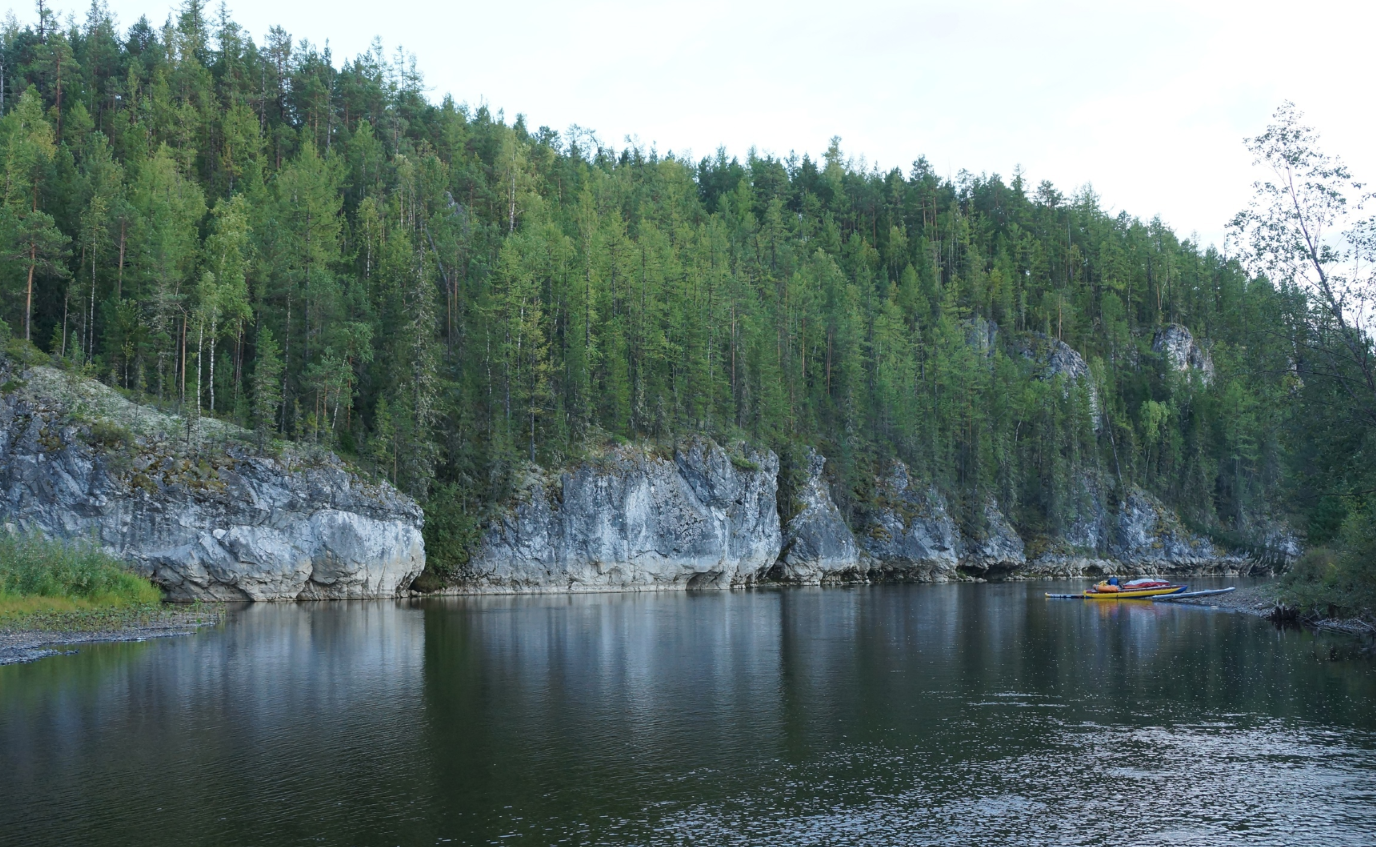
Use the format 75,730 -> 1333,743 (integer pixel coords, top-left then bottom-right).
769,450 -> 860,584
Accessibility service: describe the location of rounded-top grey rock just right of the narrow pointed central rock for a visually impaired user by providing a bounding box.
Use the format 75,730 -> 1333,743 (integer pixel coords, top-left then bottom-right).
860,461 -> 962,582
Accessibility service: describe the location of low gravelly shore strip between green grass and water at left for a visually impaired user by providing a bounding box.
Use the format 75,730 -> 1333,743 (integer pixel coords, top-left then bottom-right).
0,604 -> 224,664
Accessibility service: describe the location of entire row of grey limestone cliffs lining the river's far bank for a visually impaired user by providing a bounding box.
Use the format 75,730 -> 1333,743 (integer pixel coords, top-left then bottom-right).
0,354 -> 1298,600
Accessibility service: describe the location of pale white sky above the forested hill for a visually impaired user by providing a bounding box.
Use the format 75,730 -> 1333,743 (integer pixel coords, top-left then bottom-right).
32,0 -> 1376,243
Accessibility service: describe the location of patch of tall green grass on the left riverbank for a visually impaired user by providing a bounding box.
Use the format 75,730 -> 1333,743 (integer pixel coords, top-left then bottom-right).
0,532 -> 162,628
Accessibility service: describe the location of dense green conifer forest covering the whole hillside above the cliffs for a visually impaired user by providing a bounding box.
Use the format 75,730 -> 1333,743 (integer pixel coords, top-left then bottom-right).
0,0 -> 1346,596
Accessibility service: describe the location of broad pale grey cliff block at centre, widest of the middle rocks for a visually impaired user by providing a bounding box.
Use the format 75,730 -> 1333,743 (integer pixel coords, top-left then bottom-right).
458,439 -> 782,591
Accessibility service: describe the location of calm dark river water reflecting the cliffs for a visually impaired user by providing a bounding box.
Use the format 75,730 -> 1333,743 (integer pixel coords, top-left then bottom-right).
0,583 -> 1376,846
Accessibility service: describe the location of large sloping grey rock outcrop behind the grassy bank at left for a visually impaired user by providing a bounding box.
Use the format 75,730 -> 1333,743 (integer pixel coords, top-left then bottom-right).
0,364 -> 425,601
